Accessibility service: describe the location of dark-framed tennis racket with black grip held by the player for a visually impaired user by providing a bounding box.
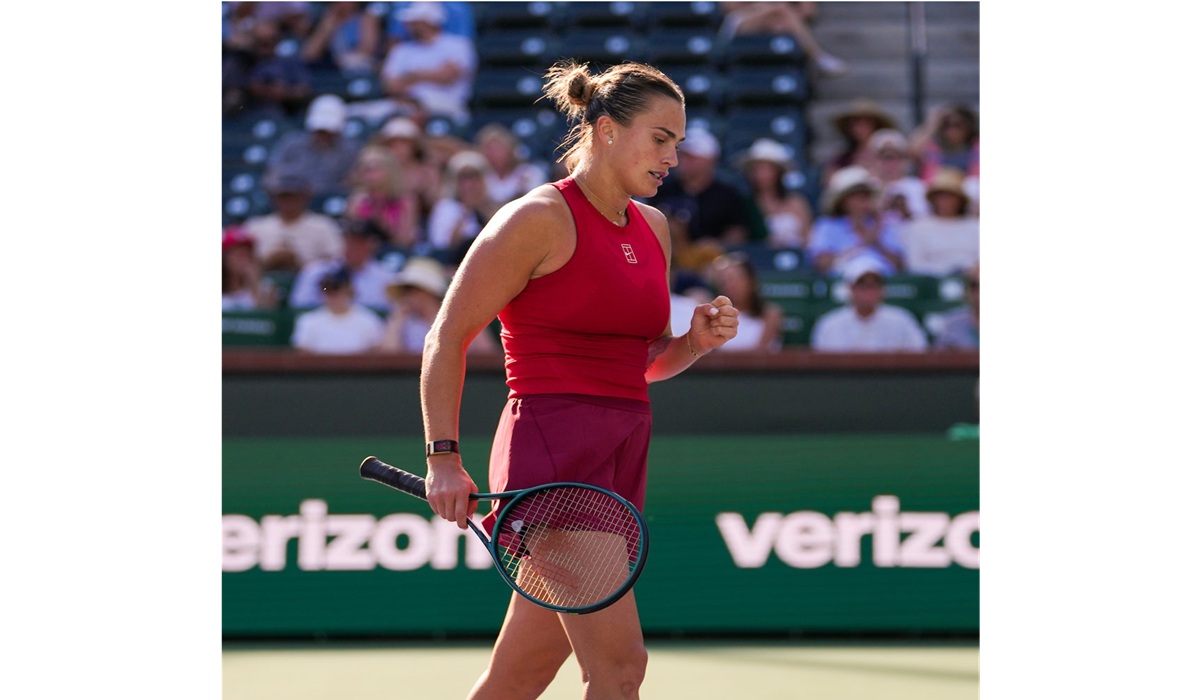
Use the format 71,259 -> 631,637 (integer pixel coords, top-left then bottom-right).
359,456 -> 650,614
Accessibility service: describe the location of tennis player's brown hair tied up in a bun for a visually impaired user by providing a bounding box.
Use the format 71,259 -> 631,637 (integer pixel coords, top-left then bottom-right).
541,59 -> 685,170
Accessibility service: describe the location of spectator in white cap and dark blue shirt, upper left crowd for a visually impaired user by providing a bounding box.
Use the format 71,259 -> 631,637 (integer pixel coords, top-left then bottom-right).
266,95 -> 362,197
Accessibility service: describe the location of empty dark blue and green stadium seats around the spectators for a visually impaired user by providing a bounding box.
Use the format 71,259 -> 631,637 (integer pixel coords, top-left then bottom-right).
222,1 -> 892,346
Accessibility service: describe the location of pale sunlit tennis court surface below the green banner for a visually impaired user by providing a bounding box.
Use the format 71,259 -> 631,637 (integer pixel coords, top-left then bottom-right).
222,640 -> 979,700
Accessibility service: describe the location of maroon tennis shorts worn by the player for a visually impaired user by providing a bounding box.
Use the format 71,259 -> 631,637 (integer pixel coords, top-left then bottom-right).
484,394 -> 652,532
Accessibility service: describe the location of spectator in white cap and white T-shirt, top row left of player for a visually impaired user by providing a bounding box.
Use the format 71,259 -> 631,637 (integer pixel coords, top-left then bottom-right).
380,2 -> 479,124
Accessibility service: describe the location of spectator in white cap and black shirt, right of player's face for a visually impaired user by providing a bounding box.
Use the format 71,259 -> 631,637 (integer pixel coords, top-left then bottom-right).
647,127 -> 750,269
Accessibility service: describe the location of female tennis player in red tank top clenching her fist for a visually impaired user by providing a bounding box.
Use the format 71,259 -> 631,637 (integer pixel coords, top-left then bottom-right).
421,61 -> 738,700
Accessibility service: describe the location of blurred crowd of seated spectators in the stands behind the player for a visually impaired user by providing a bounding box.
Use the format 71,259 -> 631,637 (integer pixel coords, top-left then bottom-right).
222,2 -> 980,353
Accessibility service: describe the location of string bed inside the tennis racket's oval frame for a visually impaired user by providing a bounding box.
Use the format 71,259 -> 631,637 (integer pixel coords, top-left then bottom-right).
497,487 -> 642,608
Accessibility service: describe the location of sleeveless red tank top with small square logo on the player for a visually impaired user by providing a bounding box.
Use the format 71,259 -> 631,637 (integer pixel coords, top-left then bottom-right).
499,178 -> 670,401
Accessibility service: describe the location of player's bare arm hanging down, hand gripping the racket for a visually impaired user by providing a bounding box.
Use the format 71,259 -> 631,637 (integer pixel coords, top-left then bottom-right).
420,189 -> 571,528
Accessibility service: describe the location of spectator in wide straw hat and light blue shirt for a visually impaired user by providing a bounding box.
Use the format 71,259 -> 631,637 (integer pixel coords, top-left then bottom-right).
806,166 -> 904,275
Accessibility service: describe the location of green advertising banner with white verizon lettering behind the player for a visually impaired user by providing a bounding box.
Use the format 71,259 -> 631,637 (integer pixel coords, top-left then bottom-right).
222,433 -> 979,639
